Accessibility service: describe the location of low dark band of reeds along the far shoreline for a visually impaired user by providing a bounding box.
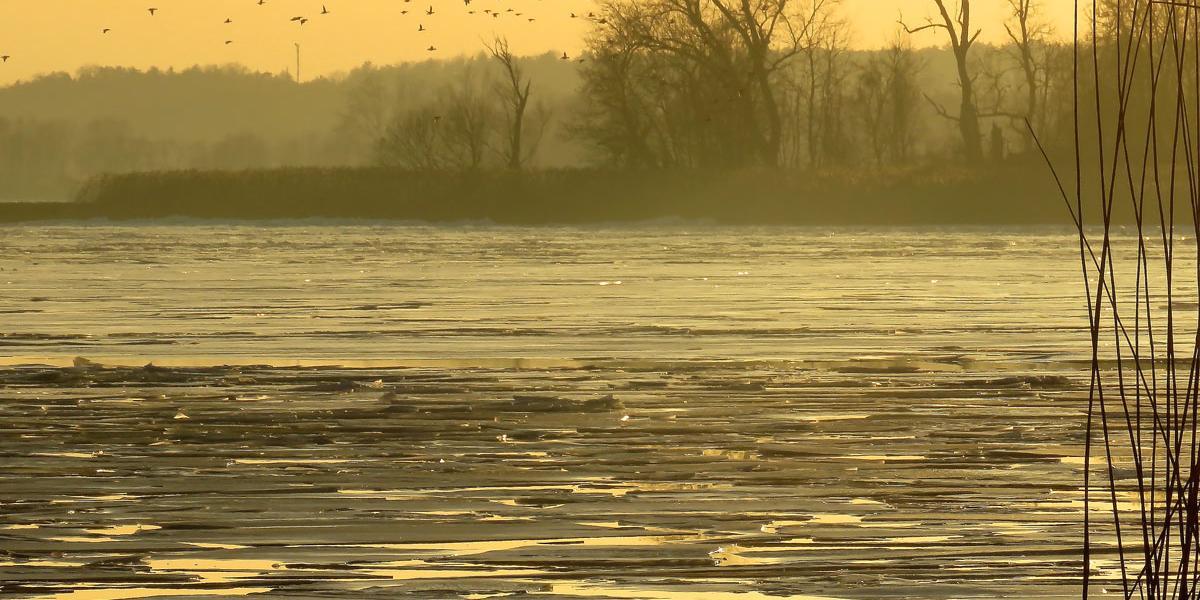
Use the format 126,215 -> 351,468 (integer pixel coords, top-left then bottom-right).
0,162 -> 1123,226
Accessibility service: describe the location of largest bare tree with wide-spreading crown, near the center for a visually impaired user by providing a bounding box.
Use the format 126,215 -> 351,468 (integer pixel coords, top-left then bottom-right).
585,0 -> 835,167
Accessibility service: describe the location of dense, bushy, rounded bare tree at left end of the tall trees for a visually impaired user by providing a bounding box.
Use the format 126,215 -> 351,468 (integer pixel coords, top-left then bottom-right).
584,0 -> 748,168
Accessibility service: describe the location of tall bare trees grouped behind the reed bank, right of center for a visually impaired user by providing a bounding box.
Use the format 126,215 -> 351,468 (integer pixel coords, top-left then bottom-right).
576,0 -> 1069,168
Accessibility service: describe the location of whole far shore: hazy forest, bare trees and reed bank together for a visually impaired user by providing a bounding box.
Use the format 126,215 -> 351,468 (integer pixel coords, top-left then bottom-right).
0,0 -> 1118,224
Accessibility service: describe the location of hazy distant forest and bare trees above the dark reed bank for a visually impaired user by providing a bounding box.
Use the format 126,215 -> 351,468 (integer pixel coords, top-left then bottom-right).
0,0 -> 1132,200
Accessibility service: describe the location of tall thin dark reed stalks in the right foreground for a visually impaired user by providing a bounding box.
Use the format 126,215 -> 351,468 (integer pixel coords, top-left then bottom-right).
1056,0 -> 1200,599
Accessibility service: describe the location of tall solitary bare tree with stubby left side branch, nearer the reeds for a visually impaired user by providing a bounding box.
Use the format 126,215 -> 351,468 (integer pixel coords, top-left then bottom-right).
900,0 -> 983,164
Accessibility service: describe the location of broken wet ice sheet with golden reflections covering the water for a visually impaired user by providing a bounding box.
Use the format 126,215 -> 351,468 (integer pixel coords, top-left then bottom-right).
0,226 -> 1118,600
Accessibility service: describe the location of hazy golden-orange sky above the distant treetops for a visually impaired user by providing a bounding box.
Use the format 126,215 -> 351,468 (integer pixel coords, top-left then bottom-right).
0,0 -> 1072,85
